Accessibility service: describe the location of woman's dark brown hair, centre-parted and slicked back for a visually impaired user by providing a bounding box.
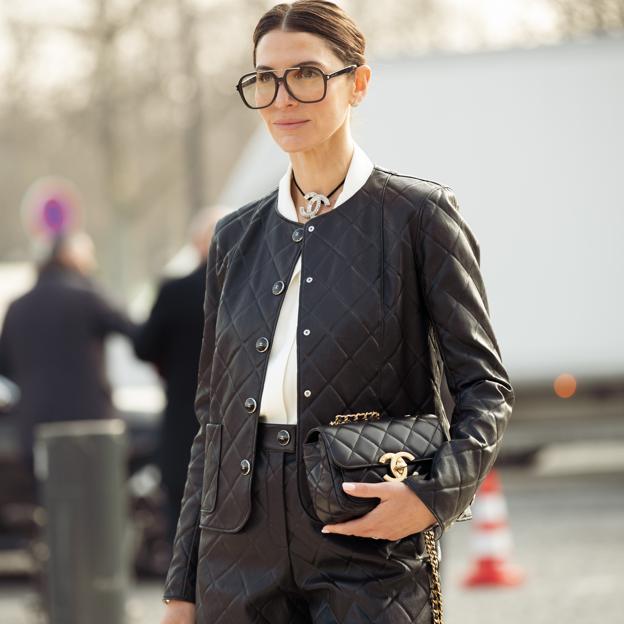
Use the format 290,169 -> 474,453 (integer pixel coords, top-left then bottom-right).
253,0 -> 366,65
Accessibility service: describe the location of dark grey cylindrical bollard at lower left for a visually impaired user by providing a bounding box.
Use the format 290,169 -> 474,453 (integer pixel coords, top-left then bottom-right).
35,419 -> 131,624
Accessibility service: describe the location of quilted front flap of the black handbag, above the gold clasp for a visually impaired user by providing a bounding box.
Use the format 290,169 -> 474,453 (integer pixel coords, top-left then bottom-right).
318,414 -> 445,468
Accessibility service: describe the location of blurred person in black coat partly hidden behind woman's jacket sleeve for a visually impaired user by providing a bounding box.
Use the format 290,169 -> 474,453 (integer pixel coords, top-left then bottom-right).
134,207 -> 228,544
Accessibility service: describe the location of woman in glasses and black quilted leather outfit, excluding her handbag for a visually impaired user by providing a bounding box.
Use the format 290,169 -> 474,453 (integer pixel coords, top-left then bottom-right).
163,0 -> 513,624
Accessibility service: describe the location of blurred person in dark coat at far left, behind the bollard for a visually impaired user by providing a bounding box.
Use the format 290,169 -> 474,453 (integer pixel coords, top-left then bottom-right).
0,232 -> 135,470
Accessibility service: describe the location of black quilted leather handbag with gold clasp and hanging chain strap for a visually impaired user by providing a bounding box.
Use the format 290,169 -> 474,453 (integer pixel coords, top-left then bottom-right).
303,412 -> 446,624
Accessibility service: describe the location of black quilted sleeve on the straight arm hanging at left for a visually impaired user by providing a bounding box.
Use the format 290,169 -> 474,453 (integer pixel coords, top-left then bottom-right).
163,227 -> 225,602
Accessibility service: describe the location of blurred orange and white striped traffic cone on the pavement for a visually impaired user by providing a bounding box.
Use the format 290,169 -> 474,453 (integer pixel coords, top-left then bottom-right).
462,470 -> 525,587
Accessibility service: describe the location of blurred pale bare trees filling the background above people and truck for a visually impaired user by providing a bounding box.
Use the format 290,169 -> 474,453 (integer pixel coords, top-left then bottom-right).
0,0 -> 624,295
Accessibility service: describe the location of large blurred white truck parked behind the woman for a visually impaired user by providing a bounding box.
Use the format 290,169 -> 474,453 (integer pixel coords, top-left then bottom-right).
220,37 -> 624,455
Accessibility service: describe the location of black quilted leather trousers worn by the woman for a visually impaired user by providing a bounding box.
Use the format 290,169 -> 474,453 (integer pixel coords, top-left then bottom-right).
196,422 -> 433,624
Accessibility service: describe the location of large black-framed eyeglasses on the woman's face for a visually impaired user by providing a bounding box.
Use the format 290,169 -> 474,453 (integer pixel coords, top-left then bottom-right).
236,65 -> 357,109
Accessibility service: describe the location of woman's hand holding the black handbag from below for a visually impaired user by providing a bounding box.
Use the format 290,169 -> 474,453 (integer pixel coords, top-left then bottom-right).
322,481 -> 437,541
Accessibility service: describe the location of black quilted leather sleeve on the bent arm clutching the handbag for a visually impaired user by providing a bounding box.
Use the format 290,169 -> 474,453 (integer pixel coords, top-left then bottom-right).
406,187 -> 514,539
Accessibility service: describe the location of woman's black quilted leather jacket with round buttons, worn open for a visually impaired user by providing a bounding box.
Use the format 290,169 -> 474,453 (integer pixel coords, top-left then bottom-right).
164,167 -> 514,602
